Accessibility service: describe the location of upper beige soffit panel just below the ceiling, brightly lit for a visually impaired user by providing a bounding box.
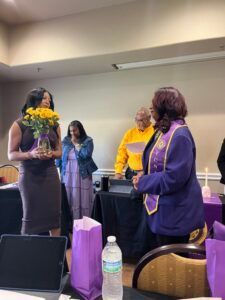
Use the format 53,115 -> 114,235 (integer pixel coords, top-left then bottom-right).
9,0 -> 225,66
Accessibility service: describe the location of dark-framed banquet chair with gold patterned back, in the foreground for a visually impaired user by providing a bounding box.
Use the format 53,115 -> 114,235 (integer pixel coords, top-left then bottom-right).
132,244 -> 210,298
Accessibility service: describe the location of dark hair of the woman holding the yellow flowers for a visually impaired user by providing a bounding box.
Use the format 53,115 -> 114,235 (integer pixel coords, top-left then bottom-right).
22,87 -> 54,116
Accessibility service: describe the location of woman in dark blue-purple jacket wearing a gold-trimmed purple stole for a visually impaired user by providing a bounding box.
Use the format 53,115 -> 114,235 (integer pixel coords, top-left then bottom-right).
133,87 -> 205,246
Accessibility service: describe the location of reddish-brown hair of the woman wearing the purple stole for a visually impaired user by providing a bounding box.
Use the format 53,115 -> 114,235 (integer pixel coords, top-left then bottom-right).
152,87 -> 187,133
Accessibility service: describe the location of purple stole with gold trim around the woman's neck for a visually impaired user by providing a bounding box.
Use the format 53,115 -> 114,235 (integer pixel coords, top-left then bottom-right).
144,121 -> 187,215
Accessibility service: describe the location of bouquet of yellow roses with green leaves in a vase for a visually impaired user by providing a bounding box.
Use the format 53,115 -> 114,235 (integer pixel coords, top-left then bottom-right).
23,107 -> 59,152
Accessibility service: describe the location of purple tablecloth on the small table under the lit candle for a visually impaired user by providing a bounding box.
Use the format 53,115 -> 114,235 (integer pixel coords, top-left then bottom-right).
203,193 -> 222,229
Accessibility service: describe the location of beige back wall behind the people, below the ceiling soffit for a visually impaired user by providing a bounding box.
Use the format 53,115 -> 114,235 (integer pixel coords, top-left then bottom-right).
1,60 -> 225,188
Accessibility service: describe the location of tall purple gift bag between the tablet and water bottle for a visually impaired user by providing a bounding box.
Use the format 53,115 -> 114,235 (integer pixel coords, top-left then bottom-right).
71,217 -> 102,300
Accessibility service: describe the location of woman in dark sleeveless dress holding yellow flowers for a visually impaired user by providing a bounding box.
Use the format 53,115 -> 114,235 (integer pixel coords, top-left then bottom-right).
8,88 -> 62,235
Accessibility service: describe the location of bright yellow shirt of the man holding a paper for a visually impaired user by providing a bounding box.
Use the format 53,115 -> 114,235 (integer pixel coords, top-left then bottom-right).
115,125 -> 154,174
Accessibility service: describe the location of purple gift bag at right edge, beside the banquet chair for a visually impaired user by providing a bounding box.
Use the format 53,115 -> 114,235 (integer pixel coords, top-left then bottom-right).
205,239 -> 225,300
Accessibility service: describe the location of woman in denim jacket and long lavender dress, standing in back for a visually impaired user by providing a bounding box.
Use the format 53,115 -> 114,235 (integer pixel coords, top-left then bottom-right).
56,121 -> 98,219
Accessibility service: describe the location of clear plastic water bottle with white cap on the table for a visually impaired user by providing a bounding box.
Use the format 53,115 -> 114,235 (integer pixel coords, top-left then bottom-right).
102,236 -> 123,300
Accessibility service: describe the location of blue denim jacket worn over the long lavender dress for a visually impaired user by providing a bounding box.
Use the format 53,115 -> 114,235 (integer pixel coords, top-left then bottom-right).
56,136 -> 98,179
